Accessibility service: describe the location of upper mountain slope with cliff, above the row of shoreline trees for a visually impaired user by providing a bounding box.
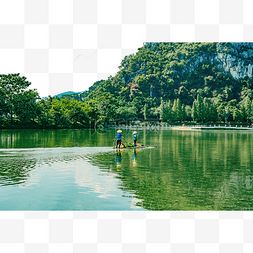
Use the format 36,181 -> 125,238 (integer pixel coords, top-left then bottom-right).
86,43 -> 253,105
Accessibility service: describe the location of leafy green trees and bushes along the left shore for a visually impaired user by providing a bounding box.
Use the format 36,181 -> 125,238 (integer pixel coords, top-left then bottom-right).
0,74 -> 95,128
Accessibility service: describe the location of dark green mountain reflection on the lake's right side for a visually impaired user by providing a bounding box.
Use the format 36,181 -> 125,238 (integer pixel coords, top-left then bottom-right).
92,131 -> 253,210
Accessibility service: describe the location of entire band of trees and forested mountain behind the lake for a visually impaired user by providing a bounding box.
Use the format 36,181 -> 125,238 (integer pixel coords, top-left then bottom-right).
0,43 -> 253,128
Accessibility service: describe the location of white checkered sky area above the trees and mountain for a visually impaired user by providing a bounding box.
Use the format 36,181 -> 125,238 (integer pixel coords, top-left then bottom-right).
0,0 -> 245,97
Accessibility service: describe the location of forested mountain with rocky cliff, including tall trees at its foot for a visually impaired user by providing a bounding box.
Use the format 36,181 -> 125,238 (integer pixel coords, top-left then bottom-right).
82,43 -> 253,124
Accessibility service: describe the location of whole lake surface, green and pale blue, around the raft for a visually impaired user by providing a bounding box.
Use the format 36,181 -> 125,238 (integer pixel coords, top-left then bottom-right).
0,130 -> 253,210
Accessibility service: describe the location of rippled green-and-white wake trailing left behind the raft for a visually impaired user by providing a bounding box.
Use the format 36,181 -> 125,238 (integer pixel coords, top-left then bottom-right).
0,148 -> 103,186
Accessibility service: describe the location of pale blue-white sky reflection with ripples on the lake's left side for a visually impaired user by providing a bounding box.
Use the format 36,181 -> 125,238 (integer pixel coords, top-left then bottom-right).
0,147 -> 144,210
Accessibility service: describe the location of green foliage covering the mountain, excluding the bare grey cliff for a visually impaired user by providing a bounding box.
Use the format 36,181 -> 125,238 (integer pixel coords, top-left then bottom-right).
81,43 -> 253,122
